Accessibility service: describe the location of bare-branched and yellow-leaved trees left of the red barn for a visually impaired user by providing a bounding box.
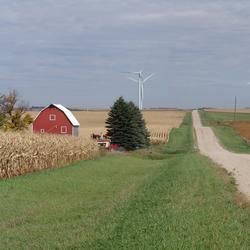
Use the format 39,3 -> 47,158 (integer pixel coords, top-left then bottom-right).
0,90 -> 33,131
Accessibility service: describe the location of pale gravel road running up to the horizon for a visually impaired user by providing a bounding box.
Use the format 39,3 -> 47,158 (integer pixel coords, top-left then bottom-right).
192,110 -> 250,200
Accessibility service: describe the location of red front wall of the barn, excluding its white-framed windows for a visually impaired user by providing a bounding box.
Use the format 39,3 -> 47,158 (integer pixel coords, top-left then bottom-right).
33,107 -> 72,135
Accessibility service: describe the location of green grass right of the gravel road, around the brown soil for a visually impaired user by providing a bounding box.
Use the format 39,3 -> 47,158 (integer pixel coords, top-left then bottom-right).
199,111 -> 250,153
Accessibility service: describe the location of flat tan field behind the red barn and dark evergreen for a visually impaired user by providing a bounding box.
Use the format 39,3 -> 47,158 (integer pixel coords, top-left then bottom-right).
30,110 -> 186,143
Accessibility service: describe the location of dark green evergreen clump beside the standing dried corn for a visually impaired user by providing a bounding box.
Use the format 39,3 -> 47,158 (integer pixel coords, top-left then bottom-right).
106,97 -> 149,150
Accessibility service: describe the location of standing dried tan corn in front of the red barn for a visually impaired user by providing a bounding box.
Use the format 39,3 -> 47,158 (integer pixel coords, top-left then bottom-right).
0,133 -> 98,178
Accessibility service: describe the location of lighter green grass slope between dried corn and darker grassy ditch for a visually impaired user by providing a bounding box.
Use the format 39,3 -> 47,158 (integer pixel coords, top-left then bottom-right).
0,155 -> 163,250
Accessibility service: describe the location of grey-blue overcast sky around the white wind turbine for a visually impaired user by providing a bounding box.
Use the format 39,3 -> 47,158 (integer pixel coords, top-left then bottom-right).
0,0 -> 250,107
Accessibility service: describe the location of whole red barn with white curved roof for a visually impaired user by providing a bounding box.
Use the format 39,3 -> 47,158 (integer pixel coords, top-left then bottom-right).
33,104 -> 80,136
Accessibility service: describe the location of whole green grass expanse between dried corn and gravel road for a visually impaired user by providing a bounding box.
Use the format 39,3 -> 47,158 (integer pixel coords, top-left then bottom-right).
0,114 -> 250,250
